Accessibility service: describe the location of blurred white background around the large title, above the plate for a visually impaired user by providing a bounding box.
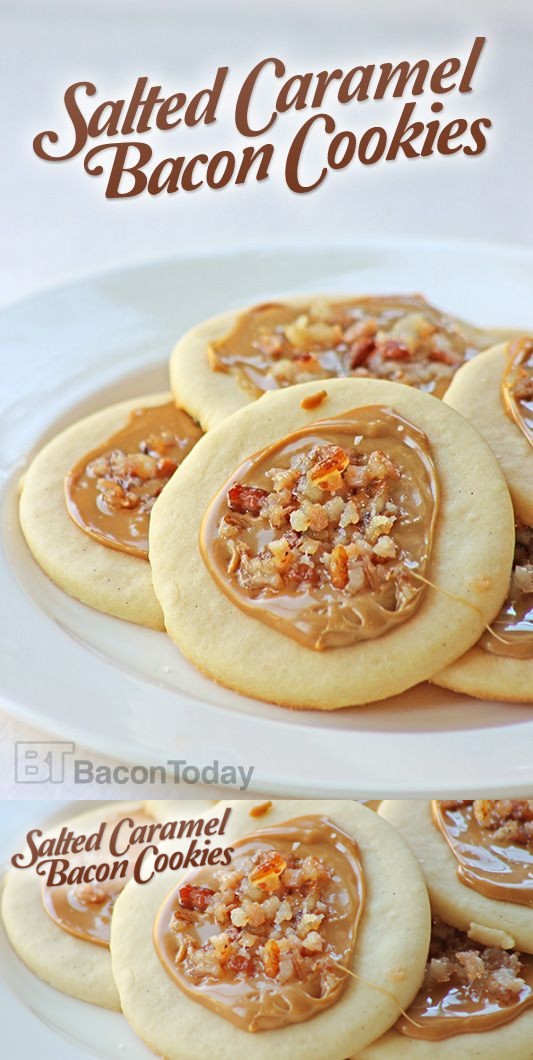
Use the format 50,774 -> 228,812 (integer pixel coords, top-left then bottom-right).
0,0 -> 533,797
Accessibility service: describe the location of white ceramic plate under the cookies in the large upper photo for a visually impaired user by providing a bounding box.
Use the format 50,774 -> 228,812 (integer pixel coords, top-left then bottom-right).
0,234 -> 533,798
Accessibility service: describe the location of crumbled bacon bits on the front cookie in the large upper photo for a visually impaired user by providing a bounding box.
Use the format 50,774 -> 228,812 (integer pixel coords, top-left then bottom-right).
218,439 -> 413,607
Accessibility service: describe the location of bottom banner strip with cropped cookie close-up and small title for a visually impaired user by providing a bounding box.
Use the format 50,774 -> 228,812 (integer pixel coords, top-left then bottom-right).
0,798 -> 533,1060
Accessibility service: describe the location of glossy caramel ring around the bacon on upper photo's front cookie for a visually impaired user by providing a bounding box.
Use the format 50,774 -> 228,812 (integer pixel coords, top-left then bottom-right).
199,406 -> 440,651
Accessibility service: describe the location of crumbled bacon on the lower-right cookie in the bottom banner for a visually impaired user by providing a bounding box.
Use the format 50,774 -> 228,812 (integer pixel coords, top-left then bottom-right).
424,920 -> 526,1006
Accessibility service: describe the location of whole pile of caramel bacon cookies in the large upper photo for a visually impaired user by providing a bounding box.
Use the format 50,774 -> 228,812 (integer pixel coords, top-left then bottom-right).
20,296 -> 533,710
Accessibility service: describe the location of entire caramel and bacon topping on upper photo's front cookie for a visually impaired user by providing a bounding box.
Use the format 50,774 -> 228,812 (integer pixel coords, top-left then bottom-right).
200,406 -> 439,651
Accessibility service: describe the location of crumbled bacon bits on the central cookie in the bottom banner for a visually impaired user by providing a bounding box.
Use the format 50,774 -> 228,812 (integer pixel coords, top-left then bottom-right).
171,849 -> 339,996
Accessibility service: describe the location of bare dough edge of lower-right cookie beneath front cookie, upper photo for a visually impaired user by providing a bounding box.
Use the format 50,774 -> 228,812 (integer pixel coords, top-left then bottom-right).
431,648 -> 533,703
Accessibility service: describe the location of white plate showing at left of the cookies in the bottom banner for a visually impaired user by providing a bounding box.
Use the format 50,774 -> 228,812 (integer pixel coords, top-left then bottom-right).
0,802 -> 154,1060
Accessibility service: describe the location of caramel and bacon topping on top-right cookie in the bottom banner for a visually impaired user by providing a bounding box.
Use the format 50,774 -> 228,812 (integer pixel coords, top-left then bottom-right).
431,799 -> 533,907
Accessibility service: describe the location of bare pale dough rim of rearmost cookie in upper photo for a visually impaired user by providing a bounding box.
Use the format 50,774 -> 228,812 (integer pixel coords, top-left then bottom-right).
170,293 -> 510,430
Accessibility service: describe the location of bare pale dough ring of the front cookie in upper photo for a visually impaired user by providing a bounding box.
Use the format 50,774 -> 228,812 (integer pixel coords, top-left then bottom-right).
149,379 -> 514,710
